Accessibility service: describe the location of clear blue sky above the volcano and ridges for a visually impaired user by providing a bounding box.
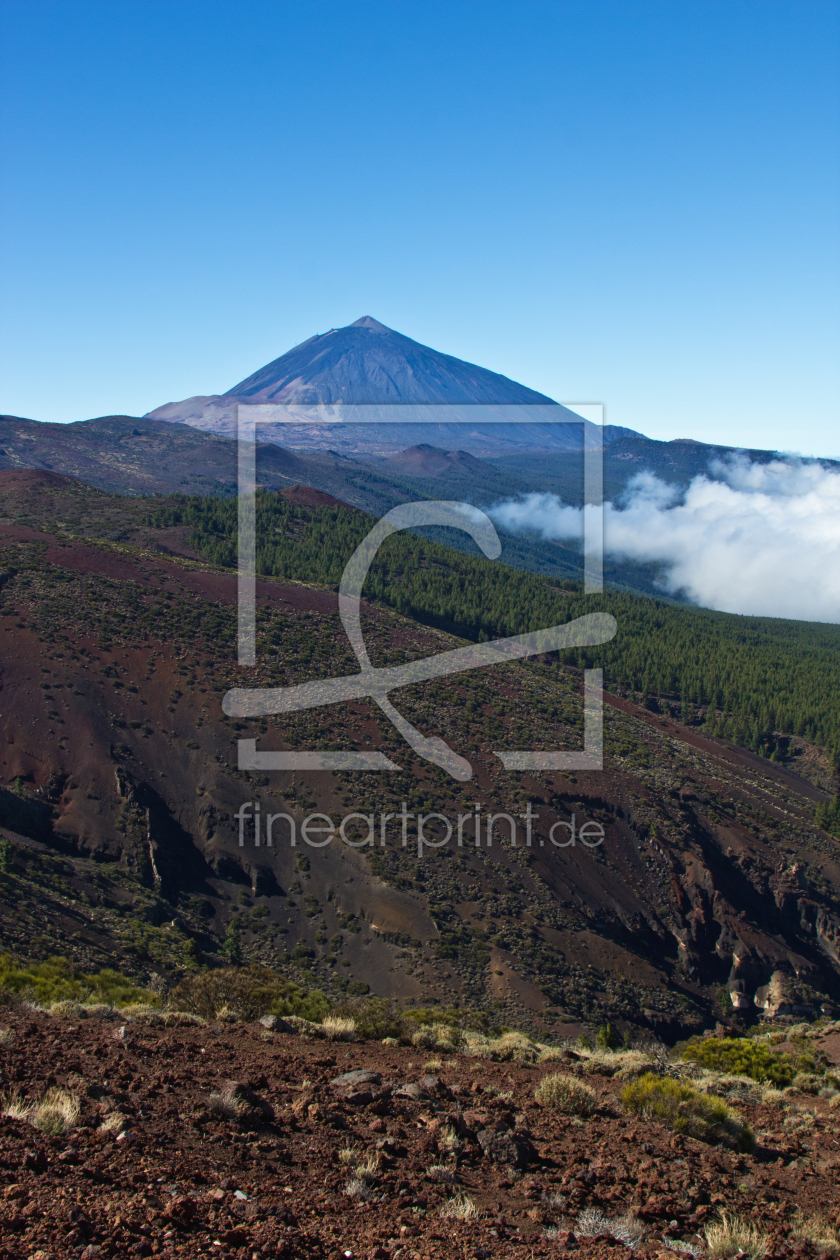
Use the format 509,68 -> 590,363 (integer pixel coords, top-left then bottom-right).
0,0 -> 840,457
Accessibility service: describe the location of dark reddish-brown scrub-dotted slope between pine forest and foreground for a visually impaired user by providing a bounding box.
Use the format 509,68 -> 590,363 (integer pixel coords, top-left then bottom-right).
0,474 -> 840,1034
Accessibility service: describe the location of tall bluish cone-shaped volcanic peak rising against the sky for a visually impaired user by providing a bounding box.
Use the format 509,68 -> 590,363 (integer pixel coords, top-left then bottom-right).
147,315 -> 644,454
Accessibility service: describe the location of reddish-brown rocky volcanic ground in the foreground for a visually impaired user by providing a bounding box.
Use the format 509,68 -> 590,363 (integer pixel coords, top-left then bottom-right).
0,1011 -> 840,1260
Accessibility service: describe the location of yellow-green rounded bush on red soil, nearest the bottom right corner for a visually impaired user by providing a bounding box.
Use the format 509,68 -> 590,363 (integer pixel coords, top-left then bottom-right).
621,1072 -> 756,1150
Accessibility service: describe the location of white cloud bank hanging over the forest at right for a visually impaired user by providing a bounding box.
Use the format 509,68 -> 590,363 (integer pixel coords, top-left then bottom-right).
490,456 -> 840,622
